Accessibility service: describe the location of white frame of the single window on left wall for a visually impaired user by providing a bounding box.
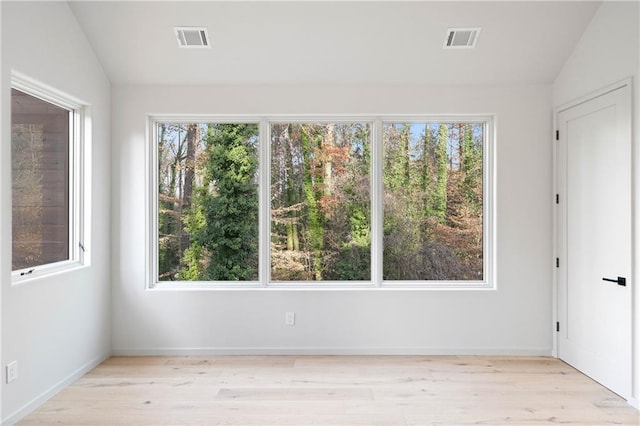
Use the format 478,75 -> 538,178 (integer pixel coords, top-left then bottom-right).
11,72 -> 90,284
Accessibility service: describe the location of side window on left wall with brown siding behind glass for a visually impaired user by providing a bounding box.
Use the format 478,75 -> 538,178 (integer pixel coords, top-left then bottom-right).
11,81 -> 84,281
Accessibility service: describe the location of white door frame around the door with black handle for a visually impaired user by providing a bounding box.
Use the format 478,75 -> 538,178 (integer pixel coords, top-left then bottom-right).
550,77 -> 639,392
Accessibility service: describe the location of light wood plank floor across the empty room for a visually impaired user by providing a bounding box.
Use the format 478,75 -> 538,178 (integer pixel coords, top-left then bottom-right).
19,356 -> 640,426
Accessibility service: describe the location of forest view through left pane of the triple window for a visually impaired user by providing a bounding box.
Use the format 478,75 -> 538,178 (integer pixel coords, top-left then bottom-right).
155,122 -> 259,282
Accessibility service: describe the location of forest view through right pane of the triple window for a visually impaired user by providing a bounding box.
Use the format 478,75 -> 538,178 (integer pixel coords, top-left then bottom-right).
383,122 -> 485,281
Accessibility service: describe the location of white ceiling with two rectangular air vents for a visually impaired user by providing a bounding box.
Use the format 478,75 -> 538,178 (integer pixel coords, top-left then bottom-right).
70,1 -> 600,85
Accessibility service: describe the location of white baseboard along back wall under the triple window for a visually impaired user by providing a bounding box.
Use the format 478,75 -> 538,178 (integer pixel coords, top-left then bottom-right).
111,347 -> 551,356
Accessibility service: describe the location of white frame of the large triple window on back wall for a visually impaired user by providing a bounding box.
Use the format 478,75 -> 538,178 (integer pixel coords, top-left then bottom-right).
146,114 -> 497,291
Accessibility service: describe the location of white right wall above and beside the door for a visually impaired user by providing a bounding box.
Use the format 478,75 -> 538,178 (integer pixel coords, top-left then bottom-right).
553,2 -> 640,407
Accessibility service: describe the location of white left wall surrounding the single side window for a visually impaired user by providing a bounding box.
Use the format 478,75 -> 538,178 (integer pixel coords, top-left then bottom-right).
0,2 -> 111,424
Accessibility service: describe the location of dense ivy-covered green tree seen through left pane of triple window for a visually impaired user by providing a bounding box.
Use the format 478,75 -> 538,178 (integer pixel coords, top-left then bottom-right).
181,124 -> 258,281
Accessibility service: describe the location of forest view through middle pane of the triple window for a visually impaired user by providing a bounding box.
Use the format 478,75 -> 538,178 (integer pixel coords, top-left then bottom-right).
270,123 -> 371,282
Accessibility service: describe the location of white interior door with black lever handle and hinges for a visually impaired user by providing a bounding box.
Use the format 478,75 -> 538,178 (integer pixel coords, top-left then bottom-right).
556,82 -> 633,398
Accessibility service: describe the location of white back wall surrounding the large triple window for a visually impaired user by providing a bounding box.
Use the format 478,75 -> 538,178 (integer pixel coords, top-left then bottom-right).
112,86 -> 552,355
